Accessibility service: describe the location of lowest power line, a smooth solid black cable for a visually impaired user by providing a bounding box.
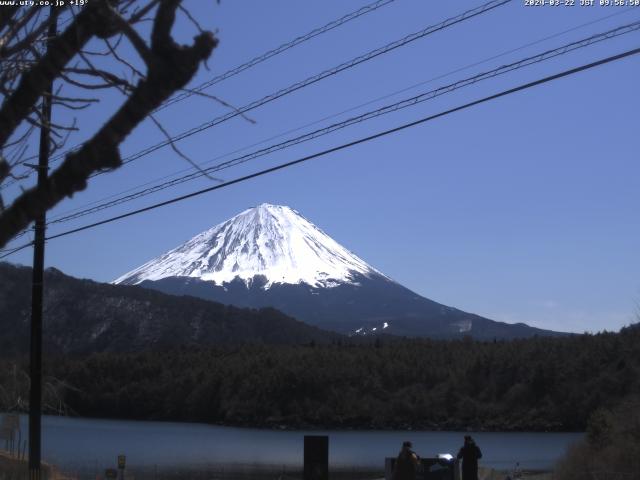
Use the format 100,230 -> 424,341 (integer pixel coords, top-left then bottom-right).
33,48 -> 640,244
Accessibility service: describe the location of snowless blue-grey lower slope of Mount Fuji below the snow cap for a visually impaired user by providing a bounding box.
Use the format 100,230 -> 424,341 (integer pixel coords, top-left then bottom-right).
140,277 -> 566,341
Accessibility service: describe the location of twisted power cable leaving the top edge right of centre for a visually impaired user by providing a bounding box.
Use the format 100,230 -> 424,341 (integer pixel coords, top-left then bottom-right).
3,0 -> 512,189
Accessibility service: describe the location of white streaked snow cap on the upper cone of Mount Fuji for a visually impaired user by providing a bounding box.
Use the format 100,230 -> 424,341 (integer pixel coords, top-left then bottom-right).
113,203 -> 382,289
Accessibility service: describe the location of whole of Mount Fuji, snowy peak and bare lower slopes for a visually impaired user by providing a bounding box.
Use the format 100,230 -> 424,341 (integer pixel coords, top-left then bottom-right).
113,204 -> 562,340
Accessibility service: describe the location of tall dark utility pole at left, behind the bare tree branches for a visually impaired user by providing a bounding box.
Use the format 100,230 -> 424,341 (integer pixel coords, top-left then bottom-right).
29,6 -> 58,480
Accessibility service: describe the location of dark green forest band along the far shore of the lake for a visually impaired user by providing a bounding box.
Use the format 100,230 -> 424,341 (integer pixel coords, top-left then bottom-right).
0,327 -> 640,431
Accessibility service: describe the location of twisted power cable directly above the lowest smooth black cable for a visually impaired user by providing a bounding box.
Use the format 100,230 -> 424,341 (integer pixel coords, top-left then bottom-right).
43,21 -> 640,225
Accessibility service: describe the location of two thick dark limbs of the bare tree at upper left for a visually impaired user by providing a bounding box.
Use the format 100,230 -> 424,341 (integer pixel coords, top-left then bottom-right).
0,0 -> 217,248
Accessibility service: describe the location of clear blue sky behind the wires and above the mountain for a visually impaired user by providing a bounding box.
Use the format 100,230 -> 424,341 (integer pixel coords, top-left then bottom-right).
2,0 -> 640,332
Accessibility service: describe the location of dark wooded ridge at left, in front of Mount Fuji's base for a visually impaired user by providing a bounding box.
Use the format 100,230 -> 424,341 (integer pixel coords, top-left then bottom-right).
0,262 -> 340,354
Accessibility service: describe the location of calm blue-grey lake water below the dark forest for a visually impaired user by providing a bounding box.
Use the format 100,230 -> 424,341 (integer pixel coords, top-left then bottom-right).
7,416 -> 582,470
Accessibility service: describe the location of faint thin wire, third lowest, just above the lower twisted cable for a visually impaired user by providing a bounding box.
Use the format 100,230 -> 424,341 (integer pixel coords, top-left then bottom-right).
46,7 -> 634,225
